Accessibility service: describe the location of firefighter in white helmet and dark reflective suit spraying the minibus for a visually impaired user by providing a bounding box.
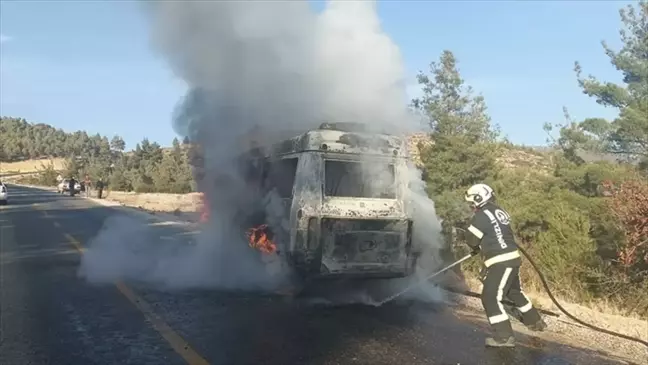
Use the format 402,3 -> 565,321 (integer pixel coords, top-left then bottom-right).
465,184 -> 547,347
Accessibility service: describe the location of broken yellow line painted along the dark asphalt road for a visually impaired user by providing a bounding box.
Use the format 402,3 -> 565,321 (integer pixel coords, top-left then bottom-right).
43,211 -> 209,365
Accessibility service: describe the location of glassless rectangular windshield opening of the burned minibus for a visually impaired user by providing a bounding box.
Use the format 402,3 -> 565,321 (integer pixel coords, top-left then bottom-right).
324,160 -> 396,199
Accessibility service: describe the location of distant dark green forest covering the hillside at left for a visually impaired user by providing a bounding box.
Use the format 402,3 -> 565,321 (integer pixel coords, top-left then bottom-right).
0,117 -> 193,193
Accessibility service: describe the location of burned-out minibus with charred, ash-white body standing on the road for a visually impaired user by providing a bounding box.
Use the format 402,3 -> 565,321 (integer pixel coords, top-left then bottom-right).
206,123 -> 420,279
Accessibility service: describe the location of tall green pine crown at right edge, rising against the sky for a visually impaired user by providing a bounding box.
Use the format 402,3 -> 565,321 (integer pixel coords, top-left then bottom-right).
548,0 -> 648,167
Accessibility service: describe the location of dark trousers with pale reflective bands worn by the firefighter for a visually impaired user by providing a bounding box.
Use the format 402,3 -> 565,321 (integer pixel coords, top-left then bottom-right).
481,262 -> 541,340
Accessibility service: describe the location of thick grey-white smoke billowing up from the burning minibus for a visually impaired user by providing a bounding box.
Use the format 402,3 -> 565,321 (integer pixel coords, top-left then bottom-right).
78,1 -> 448,302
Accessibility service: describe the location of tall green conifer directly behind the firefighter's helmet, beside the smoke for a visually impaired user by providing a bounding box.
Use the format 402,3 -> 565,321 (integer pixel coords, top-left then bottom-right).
412,51 -> 499,222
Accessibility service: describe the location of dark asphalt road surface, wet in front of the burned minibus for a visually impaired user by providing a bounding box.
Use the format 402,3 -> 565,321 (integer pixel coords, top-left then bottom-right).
0,186 -> 636,365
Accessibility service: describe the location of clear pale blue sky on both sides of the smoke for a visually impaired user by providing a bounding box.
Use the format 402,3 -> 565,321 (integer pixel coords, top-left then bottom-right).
0,0 -> 629,148
